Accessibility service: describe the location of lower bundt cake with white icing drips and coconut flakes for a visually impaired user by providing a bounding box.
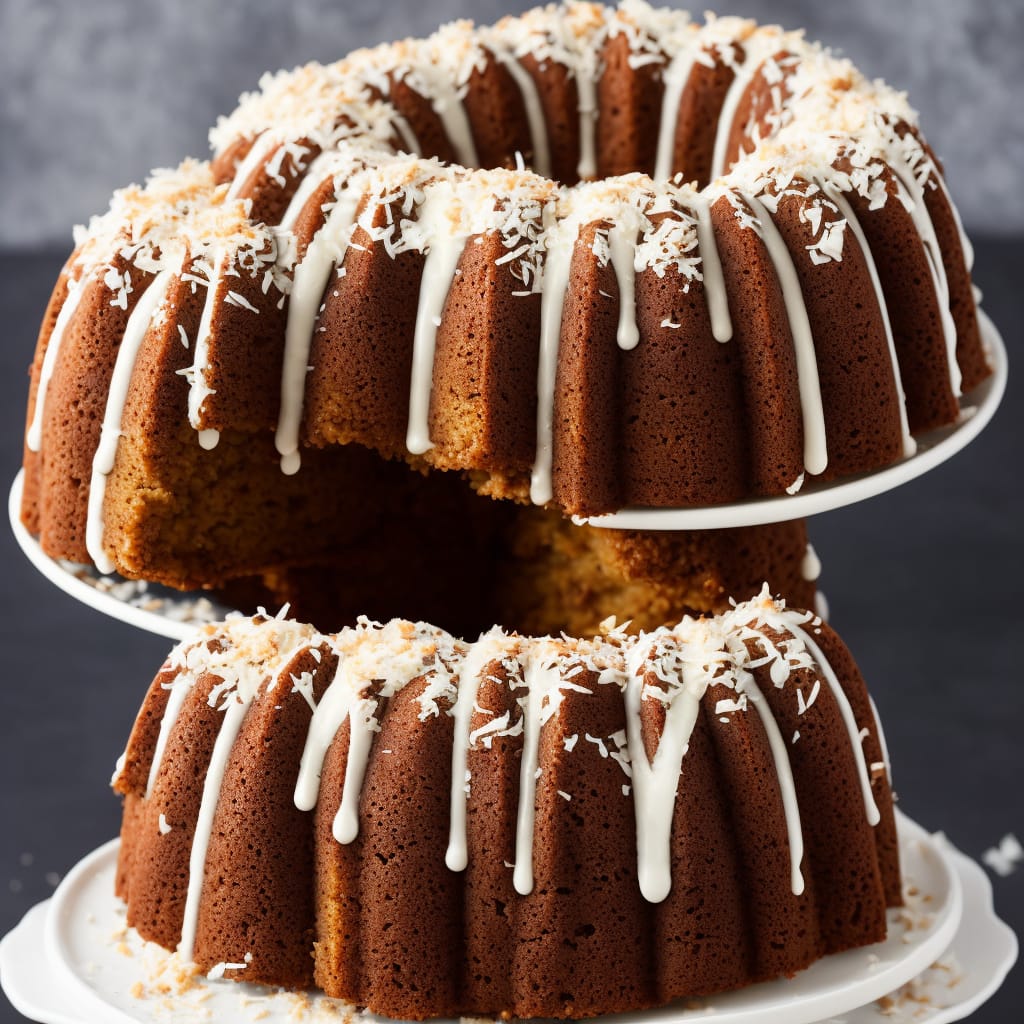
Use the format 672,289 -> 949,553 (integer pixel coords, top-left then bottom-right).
115,589 -> 900,1019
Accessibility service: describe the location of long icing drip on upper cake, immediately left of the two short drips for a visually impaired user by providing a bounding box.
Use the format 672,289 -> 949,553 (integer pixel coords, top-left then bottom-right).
529,210 -> 574,505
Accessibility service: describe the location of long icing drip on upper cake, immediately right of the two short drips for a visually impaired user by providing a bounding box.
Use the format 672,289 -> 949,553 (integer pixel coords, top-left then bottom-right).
741,193 -> 828,475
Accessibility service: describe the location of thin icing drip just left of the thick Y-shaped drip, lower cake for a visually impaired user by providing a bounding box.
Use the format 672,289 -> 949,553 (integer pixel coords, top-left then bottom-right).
512,649 -> 561,896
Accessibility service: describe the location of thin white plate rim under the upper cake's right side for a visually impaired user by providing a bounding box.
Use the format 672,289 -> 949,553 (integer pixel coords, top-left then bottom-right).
575,309 -> 1007,529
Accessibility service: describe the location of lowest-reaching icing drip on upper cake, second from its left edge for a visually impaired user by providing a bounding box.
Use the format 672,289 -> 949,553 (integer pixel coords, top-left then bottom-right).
85,270 -> 175,573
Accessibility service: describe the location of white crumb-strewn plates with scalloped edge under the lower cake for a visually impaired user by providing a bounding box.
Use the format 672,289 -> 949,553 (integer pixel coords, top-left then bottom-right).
0,816 -> 1017,1024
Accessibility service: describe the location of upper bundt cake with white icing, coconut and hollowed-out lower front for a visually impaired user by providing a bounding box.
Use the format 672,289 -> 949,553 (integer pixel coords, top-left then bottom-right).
23,0 -> 989,631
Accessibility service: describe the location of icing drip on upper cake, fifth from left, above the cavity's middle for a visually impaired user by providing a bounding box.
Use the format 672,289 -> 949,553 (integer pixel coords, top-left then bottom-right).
406,187 -> 467,455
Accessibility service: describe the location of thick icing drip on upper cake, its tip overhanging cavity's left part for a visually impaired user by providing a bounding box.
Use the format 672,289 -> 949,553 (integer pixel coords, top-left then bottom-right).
274,189 -> 361,474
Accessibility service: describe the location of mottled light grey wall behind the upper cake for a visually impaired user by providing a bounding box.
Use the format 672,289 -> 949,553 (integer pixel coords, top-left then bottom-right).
0,0 -> 1024,249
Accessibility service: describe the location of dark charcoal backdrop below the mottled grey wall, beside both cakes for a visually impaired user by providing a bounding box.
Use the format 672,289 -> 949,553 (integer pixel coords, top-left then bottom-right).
0,241 -> 1024,1024
